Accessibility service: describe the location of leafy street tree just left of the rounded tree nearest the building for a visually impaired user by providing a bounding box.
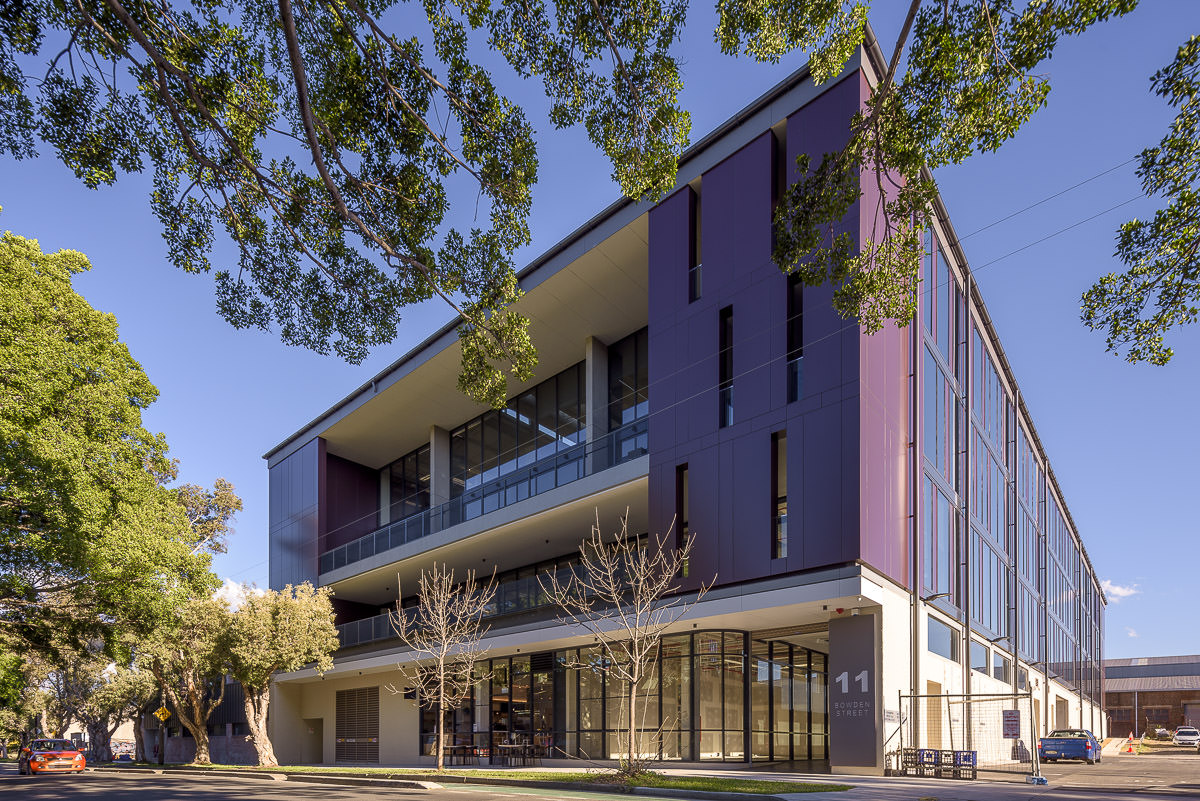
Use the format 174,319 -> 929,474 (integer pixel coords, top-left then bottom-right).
143,597 -> 230,765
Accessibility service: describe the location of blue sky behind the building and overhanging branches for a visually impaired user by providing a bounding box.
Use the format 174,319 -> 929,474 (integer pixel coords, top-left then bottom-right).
0,0 -> 1200,657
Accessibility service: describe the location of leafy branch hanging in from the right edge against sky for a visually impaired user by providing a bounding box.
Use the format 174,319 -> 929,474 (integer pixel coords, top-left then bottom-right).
1082,36 -> 1200,365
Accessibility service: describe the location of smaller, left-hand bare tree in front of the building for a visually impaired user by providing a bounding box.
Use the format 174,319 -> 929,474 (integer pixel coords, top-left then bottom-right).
391,564 -> 496,772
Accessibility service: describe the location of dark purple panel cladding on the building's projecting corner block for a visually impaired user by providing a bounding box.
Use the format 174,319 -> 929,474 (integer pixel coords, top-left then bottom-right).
649,68 -> 910,592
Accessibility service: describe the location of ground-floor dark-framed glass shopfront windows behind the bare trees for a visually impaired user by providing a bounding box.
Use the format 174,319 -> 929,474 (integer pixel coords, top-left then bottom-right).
421,631 -> 828,761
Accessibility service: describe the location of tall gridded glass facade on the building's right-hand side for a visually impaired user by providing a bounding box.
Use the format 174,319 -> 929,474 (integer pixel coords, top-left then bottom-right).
920,234 -> 1103,701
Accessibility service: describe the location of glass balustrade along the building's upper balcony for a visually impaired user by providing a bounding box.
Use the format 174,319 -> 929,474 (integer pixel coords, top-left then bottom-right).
317,418 -> 648,575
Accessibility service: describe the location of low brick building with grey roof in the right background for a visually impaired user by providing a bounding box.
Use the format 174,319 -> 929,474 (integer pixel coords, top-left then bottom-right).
1104,655 -> 1200,736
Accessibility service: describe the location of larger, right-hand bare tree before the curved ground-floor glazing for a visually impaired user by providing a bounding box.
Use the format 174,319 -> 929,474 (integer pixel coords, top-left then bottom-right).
540,510 -> 716,776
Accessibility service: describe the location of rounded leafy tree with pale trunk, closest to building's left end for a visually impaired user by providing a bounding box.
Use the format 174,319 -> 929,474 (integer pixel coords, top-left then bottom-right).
229,583 -> 338,766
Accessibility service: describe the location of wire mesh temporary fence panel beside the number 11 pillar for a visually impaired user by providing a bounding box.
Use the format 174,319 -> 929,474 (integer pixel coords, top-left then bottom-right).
888,693 -> 1039,779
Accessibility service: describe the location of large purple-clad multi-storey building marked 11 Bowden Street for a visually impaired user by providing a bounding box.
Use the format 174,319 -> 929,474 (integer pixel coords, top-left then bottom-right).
265,34 -> 1105,771
